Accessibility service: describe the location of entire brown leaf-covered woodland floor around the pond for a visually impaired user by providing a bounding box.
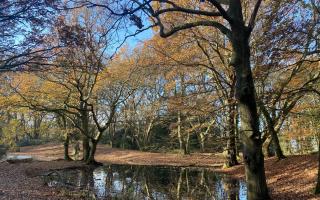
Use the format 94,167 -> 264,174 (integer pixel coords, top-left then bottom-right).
0,144 -> 320,200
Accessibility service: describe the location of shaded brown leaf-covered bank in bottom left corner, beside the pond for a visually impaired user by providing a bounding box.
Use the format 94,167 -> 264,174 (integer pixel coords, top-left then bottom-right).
0,161 -> 85,200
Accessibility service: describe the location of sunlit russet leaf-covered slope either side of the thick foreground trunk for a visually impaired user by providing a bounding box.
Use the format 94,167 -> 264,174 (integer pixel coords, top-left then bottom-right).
218,155 -> 320,200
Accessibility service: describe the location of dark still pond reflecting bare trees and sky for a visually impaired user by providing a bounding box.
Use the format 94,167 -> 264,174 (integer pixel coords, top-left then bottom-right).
45,165 -> 247,200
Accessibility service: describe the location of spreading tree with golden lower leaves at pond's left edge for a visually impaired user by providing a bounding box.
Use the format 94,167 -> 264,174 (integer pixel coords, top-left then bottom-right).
6,8 -> 134,164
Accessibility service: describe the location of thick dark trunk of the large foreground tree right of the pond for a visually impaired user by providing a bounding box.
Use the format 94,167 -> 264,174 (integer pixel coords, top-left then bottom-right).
230,23 -> 270,200
